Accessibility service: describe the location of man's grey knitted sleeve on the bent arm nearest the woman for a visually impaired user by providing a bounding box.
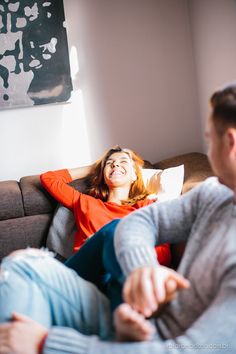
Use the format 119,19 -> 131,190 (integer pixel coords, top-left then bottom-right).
114,181 -> 202,276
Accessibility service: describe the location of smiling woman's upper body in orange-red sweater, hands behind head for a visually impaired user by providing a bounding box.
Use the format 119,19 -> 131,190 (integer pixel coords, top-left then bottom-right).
40,146 -> 170,265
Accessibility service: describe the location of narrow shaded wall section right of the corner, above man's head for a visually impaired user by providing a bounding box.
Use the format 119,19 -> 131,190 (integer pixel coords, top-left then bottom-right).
189,0 -> 236,151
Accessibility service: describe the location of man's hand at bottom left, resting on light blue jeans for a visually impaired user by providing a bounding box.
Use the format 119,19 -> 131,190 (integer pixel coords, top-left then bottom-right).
0,313 -> 48,354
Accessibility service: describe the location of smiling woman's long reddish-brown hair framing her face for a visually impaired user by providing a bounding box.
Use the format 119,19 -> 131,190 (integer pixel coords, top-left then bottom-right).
86,146 -> 148,205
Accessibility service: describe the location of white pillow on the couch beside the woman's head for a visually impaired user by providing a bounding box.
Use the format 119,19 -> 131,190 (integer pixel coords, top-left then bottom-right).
142,165 -> 184,201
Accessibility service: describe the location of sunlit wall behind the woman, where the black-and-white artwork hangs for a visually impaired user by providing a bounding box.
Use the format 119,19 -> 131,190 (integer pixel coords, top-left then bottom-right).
0,0 -> 202,180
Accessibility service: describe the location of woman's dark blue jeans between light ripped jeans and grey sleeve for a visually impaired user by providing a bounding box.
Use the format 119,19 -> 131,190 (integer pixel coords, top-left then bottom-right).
65,219 -> 124,309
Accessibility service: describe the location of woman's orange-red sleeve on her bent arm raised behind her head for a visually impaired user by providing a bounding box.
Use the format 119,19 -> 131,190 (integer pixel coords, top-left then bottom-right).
40,169 -> 81,210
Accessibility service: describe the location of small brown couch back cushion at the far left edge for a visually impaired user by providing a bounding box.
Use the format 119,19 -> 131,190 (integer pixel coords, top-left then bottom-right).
0,181 -> 24,220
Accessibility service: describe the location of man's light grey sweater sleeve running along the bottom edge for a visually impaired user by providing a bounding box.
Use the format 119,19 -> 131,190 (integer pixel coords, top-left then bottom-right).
43,265 -> 236,354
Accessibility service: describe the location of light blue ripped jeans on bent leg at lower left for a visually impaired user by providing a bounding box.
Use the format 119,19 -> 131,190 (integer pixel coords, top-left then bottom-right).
0,249 -> 113,339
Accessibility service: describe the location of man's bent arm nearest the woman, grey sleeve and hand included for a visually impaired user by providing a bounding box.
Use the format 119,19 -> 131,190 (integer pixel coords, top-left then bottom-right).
114,182 -> 215,317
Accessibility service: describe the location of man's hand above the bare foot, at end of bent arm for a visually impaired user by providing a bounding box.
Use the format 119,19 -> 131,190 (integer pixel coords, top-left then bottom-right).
123,266 -> 190,317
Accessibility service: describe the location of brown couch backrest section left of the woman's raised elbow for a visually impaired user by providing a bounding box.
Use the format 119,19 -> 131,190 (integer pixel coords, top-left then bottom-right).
0,176 -> 57,259
